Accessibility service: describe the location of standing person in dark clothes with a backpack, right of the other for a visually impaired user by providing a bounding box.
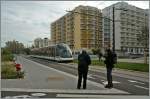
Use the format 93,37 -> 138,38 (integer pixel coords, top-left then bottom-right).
104,49 -> 117,88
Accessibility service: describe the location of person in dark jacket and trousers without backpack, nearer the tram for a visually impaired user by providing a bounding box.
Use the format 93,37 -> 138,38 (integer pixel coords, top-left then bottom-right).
77,50 -> 91,89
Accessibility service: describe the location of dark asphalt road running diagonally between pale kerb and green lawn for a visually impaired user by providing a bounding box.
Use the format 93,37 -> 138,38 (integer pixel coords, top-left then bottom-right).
26,58 -> 149,95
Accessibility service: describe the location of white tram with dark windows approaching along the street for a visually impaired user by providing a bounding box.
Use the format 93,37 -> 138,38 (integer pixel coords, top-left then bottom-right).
31,43 -> 73,62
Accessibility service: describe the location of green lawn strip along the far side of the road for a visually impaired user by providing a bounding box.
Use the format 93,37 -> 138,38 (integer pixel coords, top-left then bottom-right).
74,60 -> 149,72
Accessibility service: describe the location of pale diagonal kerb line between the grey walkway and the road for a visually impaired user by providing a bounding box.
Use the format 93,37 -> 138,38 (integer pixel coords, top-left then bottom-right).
20,58 -> 129,94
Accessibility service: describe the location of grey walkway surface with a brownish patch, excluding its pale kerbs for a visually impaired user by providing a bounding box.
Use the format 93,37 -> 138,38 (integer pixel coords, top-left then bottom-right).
2,56 -> 101,89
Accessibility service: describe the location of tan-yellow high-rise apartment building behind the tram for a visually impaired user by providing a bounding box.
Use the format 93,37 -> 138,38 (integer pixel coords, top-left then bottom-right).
51,5 -> 102,51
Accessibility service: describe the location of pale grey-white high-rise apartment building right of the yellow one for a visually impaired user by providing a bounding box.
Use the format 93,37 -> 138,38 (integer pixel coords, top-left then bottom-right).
102,2 -> 149,54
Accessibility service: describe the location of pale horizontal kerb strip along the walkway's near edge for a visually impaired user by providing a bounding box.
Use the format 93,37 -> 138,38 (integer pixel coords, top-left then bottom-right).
1,88 -> 129,95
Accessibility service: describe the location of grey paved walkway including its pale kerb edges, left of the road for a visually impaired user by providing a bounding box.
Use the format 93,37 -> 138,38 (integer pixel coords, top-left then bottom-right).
1,56 -> 128,94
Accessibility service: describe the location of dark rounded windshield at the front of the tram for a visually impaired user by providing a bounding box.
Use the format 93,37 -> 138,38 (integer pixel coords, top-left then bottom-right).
57,45 -> 72,58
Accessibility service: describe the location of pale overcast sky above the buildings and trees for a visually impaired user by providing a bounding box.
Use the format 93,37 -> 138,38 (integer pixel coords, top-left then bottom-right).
1,1 -> 149,46
